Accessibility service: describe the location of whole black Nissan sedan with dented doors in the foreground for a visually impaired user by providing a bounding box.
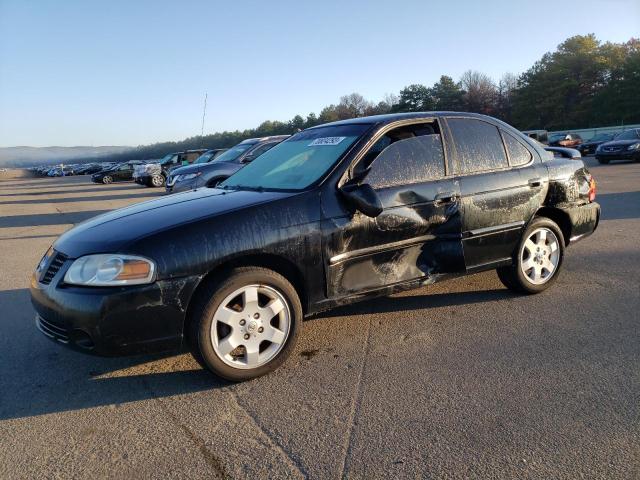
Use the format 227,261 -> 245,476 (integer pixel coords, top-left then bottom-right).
31,112 -> 600,381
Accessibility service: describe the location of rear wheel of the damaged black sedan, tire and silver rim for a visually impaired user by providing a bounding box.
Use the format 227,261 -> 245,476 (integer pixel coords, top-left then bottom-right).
497,217 -> 565,294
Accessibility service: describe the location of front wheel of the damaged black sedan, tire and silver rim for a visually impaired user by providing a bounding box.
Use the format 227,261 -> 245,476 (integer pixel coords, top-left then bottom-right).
185,267 -> 302,382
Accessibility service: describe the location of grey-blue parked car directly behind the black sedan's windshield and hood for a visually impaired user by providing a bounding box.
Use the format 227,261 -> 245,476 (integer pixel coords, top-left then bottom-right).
166,135 -> 289,193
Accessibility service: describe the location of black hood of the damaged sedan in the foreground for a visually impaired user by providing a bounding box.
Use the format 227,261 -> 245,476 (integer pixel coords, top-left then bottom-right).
53,188 -> 295,258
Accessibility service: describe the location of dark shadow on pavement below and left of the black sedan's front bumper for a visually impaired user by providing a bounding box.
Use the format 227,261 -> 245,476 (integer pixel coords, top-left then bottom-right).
0,288 -> 229,421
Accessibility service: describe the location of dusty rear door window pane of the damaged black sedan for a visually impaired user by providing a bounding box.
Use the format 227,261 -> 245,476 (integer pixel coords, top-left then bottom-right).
447,118 -> 509,174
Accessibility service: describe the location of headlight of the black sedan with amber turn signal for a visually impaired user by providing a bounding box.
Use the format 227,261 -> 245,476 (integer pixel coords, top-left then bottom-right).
64,254 -> 156,287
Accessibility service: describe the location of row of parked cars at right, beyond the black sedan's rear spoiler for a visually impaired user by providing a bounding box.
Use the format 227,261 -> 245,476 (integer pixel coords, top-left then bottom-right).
523,128 -> 640,163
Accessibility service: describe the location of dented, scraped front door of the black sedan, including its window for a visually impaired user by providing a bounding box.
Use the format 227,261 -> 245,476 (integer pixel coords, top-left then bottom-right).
323,120 -> 464,298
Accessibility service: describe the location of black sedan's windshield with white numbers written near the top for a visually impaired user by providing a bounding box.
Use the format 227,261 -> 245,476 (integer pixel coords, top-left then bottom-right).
221,124 -> 370,191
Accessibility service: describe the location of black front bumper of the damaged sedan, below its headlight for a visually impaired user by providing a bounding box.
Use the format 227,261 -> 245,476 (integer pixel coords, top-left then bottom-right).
31,261 -> 200,356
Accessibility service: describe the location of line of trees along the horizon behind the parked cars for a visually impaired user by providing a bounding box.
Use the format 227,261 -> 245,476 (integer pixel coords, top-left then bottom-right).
101,34 -> 640,161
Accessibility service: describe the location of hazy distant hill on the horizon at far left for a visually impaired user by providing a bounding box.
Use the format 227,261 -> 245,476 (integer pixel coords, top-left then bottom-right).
0,146 -> 133,167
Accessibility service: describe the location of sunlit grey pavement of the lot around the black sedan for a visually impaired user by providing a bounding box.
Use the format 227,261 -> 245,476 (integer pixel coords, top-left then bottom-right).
0,159 -> 640,479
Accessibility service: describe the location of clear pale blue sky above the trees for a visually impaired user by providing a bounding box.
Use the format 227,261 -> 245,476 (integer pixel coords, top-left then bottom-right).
0,0 -> 640,147
